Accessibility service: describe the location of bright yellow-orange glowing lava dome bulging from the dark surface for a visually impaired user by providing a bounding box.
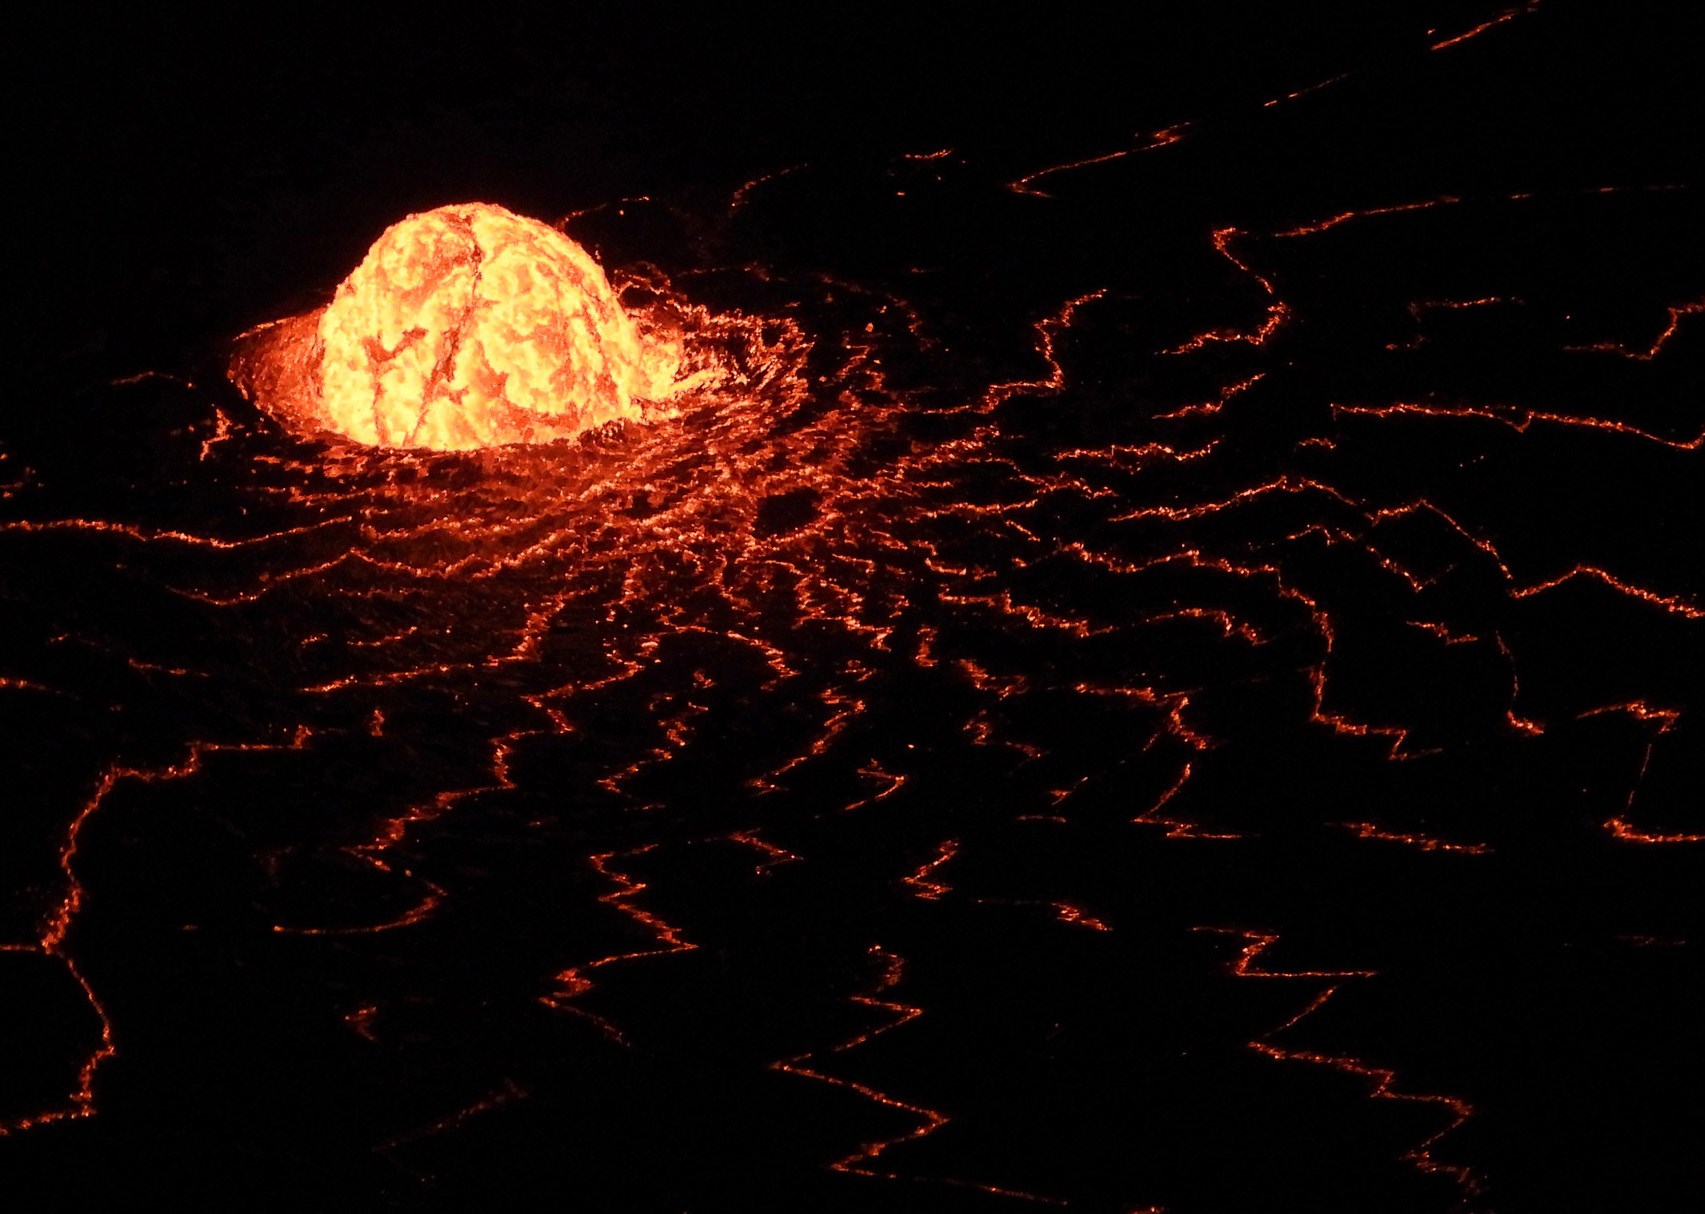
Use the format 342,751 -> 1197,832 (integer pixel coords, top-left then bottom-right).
232,203 -> 684,450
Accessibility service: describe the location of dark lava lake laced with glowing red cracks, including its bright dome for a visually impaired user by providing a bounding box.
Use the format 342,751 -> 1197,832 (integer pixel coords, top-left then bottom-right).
0,3 -> 1705,1214
